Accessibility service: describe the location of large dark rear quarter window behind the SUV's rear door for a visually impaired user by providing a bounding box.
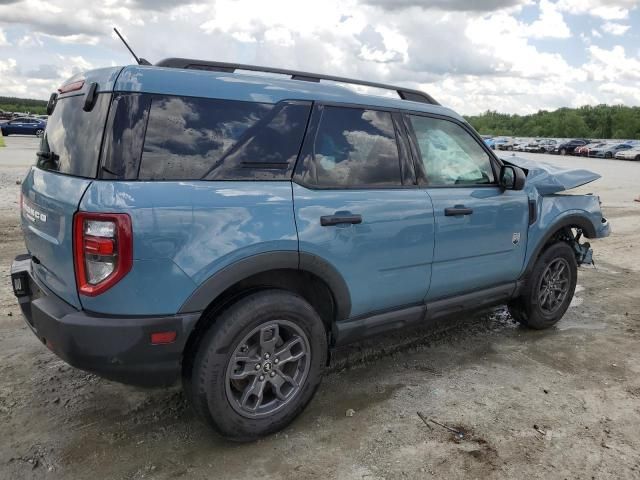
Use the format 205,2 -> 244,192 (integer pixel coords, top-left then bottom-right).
138,96 -> 311,180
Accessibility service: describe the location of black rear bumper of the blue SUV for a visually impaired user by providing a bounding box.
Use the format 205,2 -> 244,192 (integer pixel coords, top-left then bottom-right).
11,255 -> 200,387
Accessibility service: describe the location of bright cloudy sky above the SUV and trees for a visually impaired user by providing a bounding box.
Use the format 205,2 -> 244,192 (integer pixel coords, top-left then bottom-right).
0,0 -> 640,115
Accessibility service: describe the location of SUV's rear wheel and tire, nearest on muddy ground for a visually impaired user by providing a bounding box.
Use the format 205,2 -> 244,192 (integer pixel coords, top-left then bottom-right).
183,290 -> 327,442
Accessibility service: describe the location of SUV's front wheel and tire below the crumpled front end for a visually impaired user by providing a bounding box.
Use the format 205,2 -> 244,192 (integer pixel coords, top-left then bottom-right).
509,242 -> 578,330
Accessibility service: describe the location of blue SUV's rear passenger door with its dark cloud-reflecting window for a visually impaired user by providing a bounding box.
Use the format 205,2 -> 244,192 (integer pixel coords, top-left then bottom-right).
293,105 -> 433,317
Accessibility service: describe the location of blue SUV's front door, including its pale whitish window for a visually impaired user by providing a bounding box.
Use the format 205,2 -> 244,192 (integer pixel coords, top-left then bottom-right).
405,115 -> 529,301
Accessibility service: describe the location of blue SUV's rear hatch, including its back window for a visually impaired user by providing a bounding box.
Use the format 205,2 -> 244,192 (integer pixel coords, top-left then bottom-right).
21,68 -> 120,308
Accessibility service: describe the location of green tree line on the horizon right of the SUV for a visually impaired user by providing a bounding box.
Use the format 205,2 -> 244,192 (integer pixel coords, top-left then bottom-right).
465,105 -> 640,140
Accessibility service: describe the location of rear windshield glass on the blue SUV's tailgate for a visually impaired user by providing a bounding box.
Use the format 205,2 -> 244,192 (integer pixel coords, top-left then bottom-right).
36,93 -> 111,178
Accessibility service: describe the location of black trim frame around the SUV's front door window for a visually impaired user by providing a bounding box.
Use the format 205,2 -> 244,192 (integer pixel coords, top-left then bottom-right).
402,111 -> 503,188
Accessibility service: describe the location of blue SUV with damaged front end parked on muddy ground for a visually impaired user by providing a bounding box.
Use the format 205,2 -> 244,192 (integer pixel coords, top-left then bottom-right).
11,59 -> 609,440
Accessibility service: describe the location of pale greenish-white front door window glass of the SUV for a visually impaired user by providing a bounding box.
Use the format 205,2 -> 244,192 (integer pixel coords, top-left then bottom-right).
409,115 -> 494,185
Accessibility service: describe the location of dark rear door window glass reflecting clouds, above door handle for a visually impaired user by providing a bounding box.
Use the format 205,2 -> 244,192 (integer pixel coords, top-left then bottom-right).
303,107 -> 402,187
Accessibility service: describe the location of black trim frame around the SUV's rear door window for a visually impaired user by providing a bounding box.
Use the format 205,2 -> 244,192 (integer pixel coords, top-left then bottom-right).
291,101 -> 419,191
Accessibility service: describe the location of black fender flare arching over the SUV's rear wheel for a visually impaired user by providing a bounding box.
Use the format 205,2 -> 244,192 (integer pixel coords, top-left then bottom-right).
178,250 -> 351,321
